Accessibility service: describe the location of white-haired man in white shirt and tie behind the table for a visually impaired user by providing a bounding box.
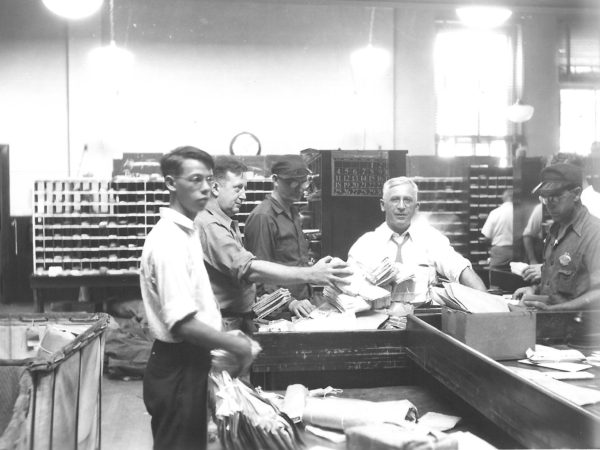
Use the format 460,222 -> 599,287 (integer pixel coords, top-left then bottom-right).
348,177 -> 486,291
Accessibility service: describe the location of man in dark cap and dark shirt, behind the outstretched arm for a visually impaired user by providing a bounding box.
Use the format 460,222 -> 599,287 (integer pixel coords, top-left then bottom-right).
244,155 -> 314,316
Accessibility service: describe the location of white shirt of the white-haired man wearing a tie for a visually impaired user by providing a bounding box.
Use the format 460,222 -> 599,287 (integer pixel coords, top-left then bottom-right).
348,219 -> 471,282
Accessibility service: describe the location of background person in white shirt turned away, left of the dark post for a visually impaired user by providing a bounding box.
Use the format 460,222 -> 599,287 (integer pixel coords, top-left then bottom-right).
481,189 -> 513,269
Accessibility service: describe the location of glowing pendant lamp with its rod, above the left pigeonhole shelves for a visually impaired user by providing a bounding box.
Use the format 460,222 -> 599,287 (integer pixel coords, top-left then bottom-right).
89,0 -> 134,87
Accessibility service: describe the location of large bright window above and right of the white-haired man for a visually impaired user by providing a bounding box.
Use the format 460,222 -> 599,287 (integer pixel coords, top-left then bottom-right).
434,29 -> 513,158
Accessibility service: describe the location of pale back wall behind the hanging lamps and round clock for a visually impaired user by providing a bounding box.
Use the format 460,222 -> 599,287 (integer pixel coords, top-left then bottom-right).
0,0 -> 584,215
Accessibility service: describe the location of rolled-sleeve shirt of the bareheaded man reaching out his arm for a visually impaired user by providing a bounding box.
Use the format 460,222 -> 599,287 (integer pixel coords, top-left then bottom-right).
196,201 -> 256,313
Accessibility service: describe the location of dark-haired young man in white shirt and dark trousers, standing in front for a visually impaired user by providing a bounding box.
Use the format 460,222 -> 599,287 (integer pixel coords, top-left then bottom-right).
140,147 -> 252,450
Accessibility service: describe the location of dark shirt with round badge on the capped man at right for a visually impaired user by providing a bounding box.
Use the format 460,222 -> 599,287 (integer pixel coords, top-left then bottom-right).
539,205 -> 600,303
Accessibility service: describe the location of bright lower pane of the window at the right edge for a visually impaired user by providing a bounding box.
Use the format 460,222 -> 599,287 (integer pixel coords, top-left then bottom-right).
560,89 -> 600,155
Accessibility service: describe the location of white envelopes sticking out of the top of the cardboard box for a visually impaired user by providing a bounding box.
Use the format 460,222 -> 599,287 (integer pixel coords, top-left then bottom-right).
429,283 -> 509,313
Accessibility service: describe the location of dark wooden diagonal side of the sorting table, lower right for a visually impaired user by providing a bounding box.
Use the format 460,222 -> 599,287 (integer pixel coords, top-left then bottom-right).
406,314 -> 600,448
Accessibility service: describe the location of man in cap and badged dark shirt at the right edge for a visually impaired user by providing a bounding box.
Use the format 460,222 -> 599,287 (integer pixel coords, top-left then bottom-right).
514,163 -> 600,310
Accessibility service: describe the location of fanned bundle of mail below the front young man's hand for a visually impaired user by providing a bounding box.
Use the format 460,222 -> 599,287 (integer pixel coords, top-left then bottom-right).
209,371 -> 303,450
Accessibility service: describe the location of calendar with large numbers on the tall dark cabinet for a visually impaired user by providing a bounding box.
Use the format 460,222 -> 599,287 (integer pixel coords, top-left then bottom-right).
331,151 -> 389,197
